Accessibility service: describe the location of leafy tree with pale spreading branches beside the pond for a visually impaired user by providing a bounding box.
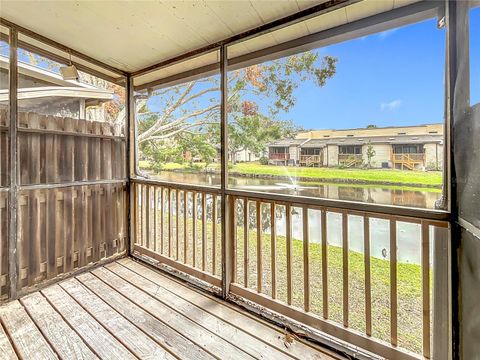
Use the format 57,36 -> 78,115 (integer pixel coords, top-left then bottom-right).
136,51 -> 337,169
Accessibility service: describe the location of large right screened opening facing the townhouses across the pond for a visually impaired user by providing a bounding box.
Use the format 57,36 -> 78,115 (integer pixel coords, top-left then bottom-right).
228,18 -> 445,208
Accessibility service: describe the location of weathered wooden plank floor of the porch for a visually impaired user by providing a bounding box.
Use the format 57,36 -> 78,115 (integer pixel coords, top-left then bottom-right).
0,259 -> 340,360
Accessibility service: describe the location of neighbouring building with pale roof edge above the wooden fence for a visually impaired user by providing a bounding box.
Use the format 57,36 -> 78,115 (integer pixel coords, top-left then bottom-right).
0,55 -> 114,121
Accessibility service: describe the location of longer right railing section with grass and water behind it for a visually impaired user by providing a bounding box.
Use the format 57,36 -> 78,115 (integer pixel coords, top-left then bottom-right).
229,196 -> 448,359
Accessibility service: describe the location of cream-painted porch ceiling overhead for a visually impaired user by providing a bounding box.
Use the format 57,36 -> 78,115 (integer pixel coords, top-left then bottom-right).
0,0 -> 415,72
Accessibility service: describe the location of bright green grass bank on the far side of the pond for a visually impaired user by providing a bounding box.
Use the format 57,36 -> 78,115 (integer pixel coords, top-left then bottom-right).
140,161 -> 442,187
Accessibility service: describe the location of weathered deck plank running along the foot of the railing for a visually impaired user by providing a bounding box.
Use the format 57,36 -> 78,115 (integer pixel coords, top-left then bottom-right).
117,259 -> 331,359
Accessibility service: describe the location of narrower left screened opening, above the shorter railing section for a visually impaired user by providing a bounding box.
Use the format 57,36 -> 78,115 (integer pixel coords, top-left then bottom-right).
134,53 -> 219,186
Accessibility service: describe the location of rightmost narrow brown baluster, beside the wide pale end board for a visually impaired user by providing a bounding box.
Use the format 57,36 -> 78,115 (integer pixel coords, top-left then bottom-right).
422,221 -> 430,358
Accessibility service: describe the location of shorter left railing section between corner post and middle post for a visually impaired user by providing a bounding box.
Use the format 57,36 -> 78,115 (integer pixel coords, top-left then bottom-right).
132,183 -> 222,288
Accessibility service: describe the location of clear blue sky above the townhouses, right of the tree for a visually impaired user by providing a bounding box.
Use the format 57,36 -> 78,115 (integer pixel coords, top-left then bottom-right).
280,8 -> 480,129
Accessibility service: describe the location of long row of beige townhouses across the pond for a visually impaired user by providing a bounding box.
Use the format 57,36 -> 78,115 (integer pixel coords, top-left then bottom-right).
268,124 -> 443,170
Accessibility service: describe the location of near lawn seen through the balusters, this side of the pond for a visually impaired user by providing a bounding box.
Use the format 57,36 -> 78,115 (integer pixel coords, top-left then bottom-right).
137,213 -> 422,353
